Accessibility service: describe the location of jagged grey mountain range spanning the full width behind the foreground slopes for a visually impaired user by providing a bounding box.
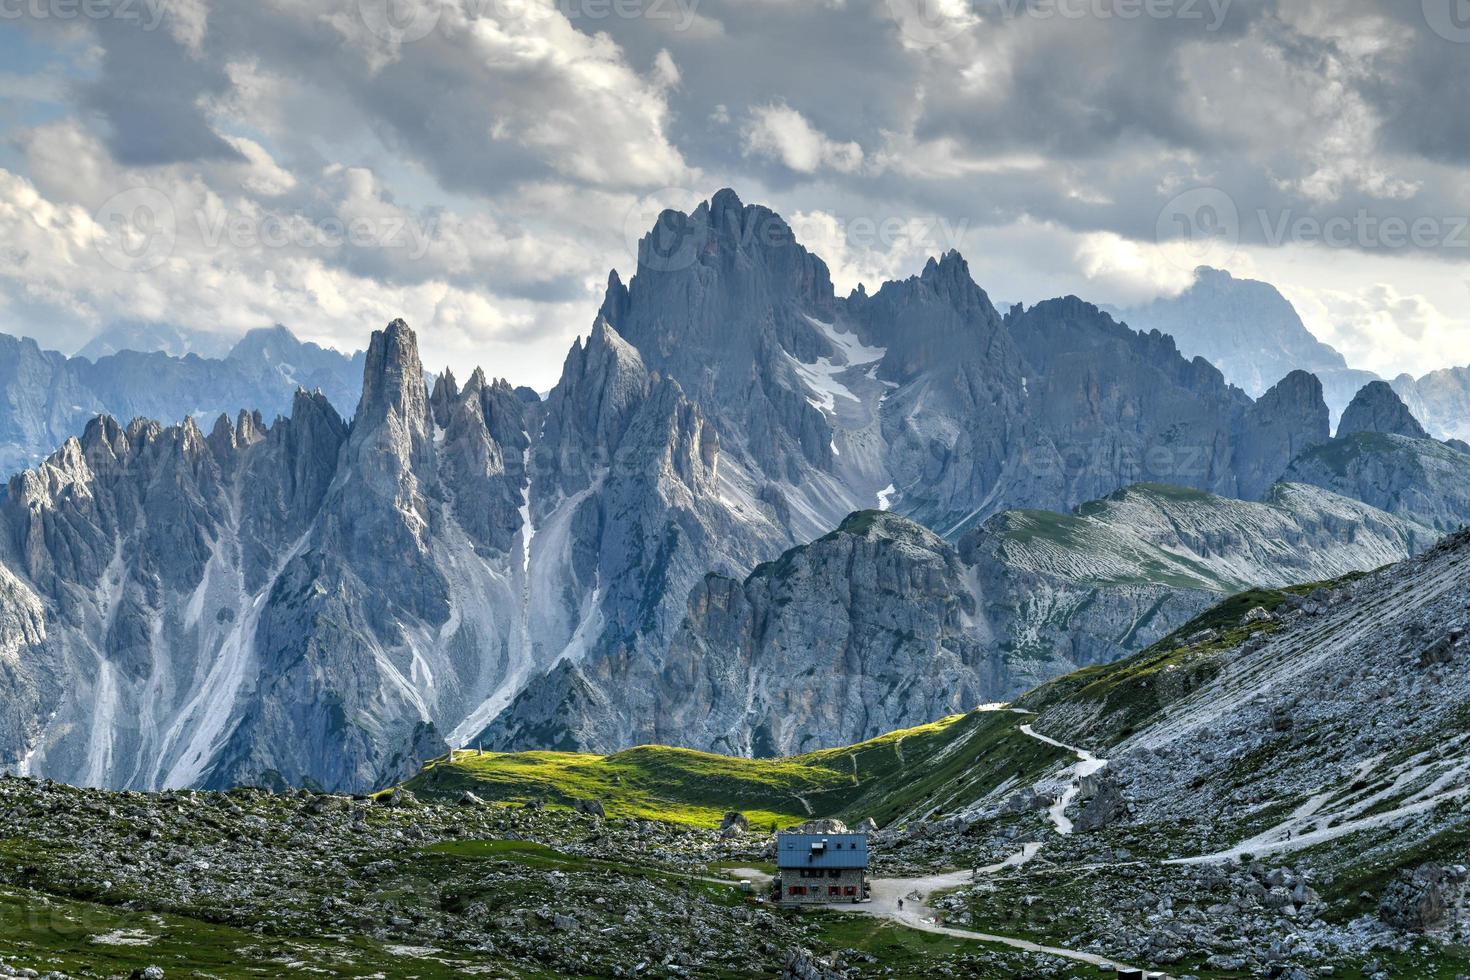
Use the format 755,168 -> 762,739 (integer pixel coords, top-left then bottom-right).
0,191 -> 1470,790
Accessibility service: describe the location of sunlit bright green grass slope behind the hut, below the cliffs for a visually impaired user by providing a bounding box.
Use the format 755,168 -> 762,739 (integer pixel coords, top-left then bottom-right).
406,711 -> 1064,827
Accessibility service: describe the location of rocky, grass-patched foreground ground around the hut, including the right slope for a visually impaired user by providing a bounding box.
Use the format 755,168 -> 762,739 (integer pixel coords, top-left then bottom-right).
0,532 -> 1470,980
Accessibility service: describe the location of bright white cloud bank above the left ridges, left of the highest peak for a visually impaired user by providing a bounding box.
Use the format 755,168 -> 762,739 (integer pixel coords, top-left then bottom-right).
0,123 -> 606,386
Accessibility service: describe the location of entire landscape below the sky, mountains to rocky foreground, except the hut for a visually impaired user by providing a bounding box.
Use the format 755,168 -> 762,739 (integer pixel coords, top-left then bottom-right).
0,190 -> 1470,980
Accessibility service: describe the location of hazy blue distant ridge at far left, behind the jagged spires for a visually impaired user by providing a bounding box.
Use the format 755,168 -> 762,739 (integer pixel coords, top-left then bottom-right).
0,326 -> 362,475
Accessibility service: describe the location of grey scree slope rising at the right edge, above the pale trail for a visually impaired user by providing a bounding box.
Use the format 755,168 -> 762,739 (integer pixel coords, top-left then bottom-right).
1020,532 -> 1470,896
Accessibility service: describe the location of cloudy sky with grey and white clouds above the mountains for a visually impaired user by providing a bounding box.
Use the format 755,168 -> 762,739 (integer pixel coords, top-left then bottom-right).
0,0 -> 1470,388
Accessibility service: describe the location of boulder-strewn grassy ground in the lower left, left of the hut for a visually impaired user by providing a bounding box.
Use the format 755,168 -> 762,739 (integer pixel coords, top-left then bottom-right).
0,777 -> 1111,980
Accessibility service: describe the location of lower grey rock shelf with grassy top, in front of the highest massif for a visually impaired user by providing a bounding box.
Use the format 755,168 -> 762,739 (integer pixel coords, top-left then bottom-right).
511,485 -> 1438,757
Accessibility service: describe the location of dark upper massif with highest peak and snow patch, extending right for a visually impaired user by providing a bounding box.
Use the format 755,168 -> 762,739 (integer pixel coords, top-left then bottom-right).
590,191 -> 1322,539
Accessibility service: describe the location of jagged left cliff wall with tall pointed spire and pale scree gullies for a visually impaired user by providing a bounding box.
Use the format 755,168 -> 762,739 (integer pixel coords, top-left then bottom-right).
3,322 -> 531,789
